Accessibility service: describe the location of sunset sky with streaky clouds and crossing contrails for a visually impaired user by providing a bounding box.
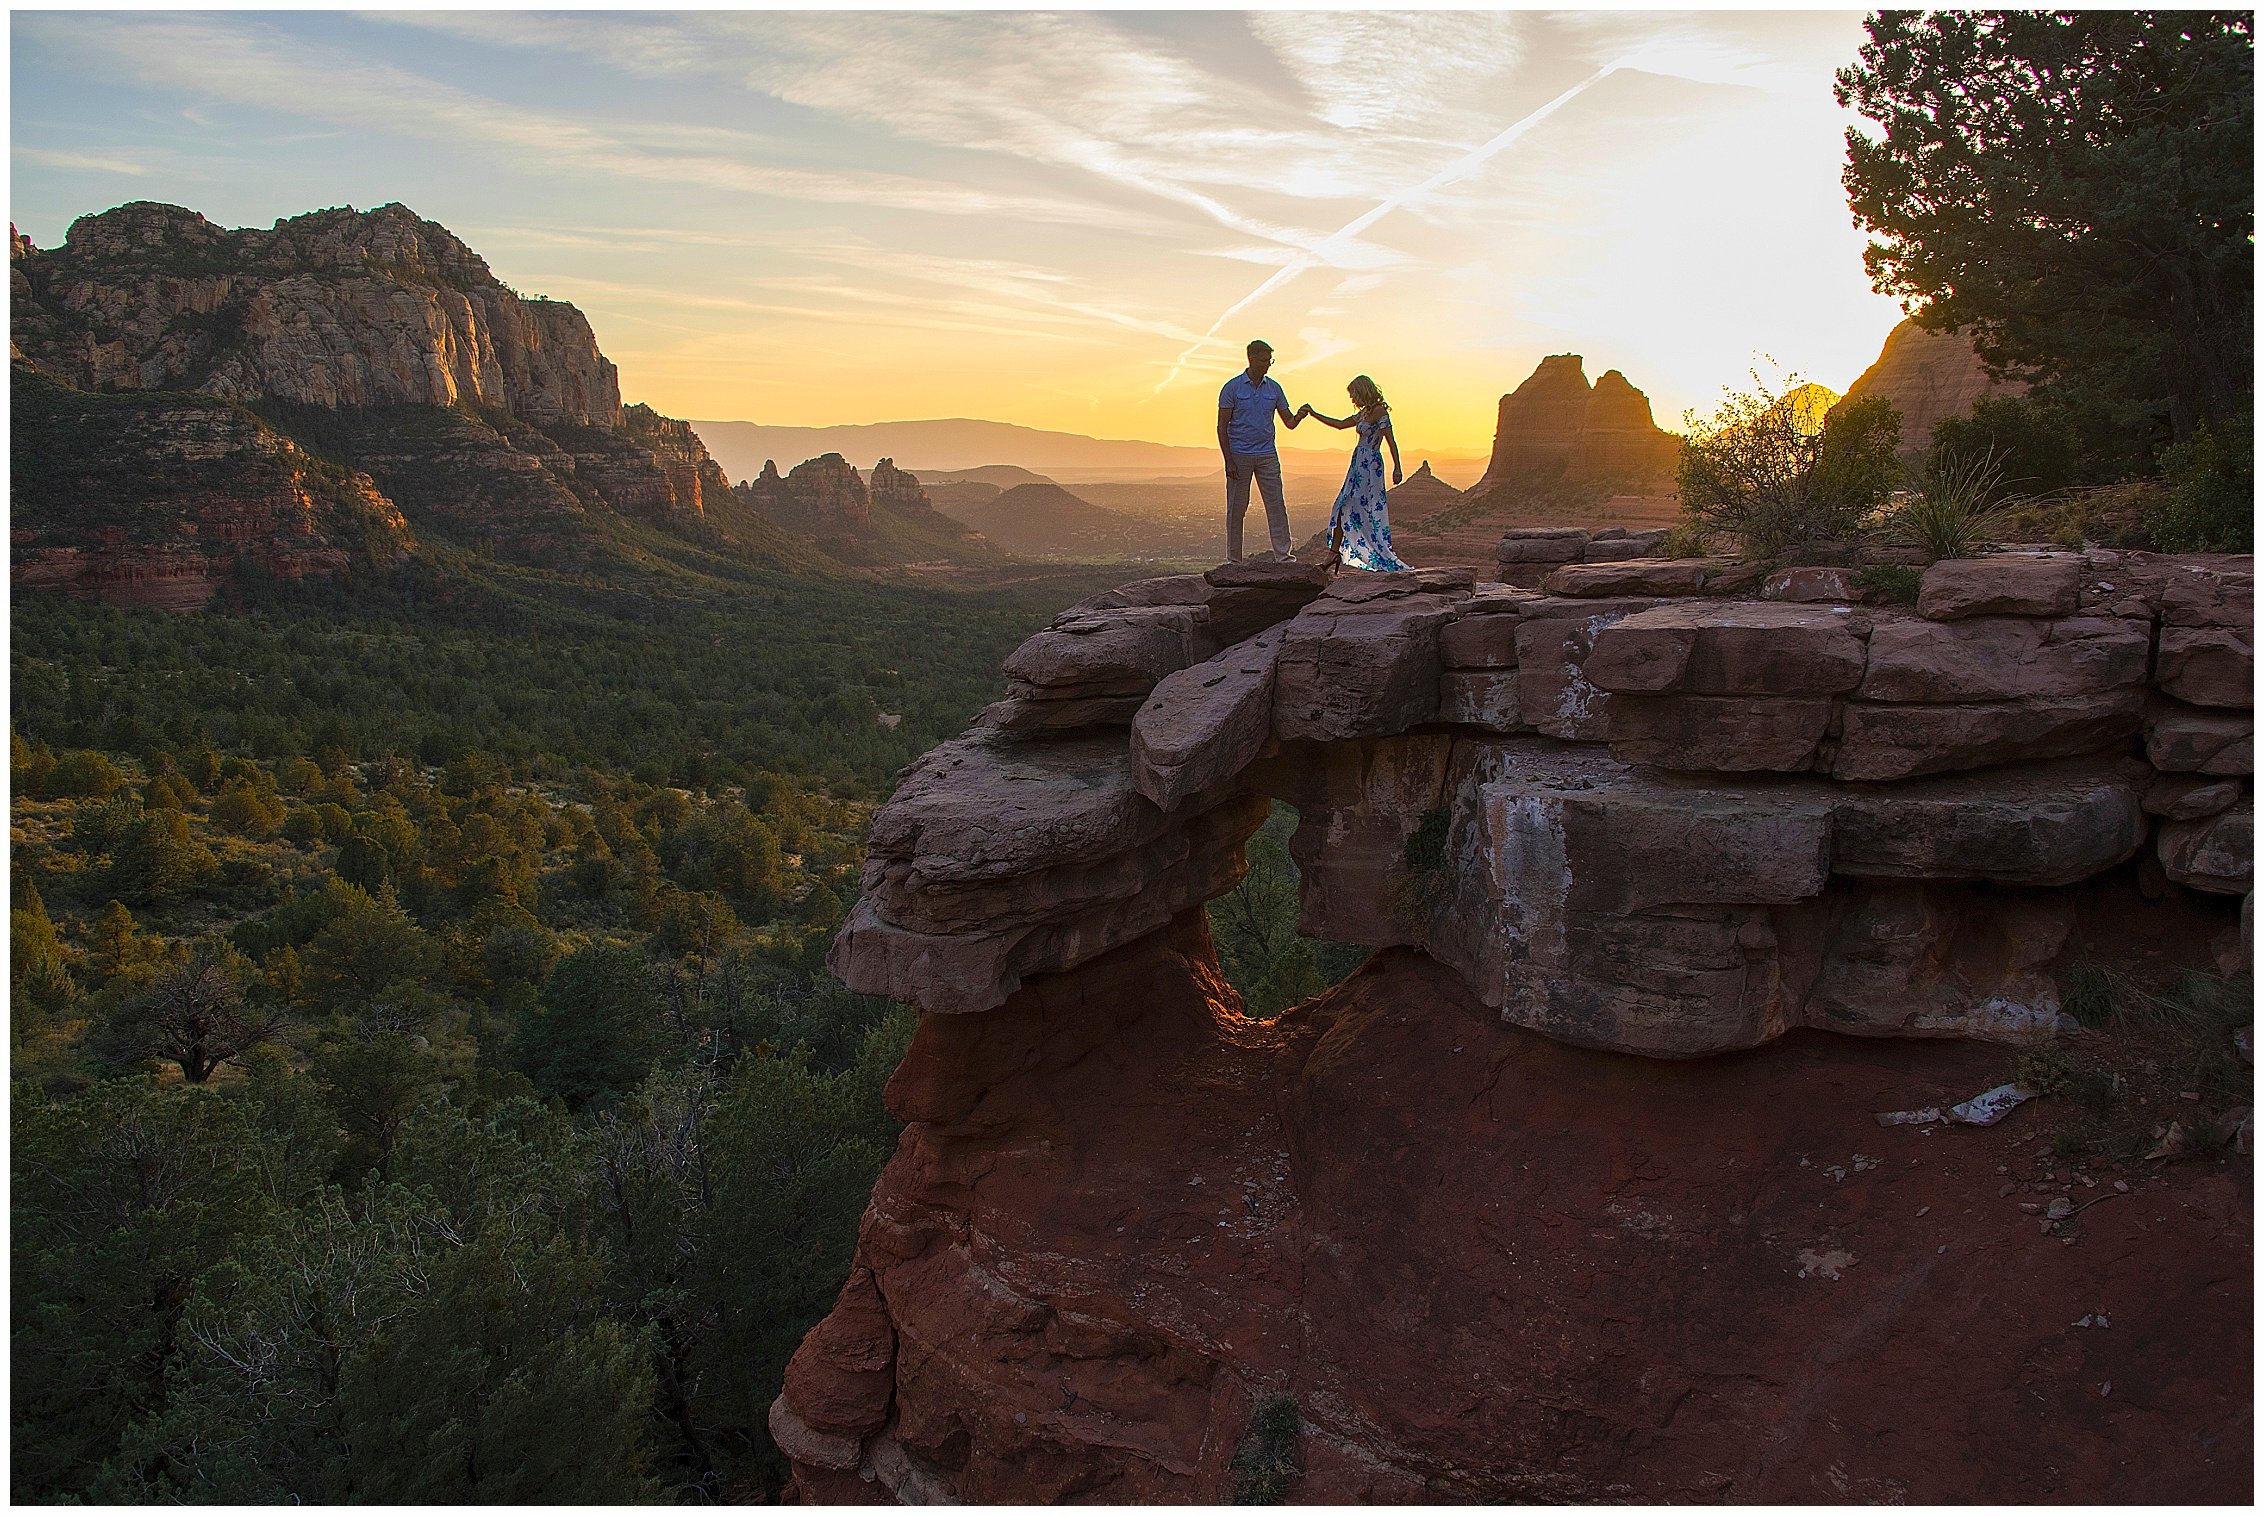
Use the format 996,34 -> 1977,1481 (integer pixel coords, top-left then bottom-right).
9,9 -> 1902,455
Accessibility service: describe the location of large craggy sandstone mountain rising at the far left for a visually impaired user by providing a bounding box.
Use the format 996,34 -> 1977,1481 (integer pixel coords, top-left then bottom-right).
9,201 -> 747,609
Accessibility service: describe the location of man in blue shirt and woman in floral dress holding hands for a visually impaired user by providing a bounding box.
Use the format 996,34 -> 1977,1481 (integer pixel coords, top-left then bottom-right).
1218,342 -> 1406,570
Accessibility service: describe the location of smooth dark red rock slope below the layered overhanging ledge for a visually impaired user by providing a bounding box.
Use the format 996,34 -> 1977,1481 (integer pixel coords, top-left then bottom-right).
788,928 -> 2253,1505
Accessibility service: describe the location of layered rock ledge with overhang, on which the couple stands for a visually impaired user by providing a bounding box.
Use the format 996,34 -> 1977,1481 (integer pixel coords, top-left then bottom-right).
833,543 -> 2253,1057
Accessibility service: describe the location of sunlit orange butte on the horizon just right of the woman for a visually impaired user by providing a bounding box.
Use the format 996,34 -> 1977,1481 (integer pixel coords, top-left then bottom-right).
1469,353 -> 1682,496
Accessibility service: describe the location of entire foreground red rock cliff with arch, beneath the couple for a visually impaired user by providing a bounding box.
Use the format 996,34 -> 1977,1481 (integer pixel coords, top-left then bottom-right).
770,549 -> 2253,1502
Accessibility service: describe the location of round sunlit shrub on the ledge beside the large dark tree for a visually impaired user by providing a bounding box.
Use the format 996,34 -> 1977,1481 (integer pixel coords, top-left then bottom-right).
1675,373 -> 1902,557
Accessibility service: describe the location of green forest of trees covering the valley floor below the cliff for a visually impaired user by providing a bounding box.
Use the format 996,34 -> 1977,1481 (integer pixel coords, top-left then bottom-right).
9,561 -> 1358,1502
